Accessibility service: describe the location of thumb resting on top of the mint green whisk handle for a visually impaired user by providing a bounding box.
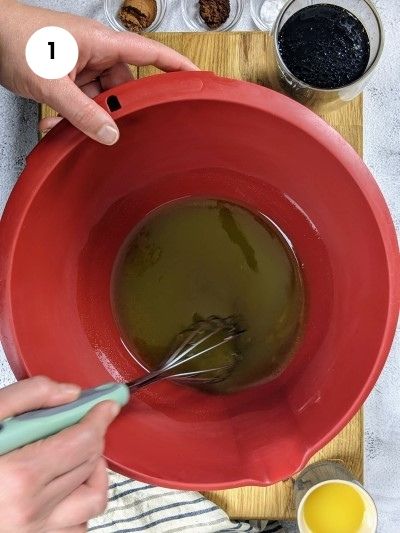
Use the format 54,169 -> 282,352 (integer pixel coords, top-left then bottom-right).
0,376 -> 80,420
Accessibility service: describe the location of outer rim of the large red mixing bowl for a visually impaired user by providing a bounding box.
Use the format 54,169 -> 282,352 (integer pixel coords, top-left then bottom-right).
0,72 -> 400,490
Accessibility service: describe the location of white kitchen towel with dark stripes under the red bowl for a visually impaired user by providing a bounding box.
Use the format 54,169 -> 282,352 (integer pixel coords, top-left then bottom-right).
88,471 -> 284,533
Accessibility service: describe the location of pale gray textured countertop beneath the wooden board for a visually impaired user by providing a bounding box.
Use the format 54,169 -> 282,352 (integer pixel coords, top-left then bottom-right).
0,0 -> 400,533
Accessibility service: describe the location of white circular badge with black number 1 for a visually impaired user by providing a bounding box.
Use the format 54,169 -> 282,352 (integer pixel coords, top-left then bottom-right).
25,26 -> 79,80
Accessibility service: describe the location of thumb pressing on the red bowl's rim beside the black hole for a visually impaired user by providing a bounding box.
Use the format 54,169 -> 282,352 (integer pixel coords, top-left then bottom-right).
45,78 -> 119,145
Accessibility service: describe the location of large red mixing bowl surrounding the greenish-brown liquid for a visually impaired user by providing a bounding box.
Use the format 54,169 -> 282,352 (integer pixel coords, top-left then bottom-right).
0,73 -> 399,489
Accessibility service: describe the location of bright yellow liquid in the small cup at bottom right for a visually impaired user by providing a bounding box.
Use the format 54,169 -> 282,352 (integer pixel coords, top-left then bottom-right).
304,483 -> 365,533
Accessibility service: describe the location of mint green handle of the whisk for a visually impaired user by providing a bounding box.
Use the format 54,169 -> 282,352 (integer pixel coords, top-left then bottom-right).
0,383 -> 130,455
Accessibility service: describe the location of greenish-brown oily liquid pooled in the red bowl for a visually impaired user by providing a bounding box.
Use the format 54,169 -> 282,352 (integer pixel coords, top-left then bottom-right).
111,199 -> 305,393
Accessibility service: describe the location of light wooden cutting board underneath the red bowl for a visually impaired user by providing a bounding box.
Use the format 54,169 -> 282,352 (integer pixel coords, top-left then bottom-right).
41,32 -> 363,519
